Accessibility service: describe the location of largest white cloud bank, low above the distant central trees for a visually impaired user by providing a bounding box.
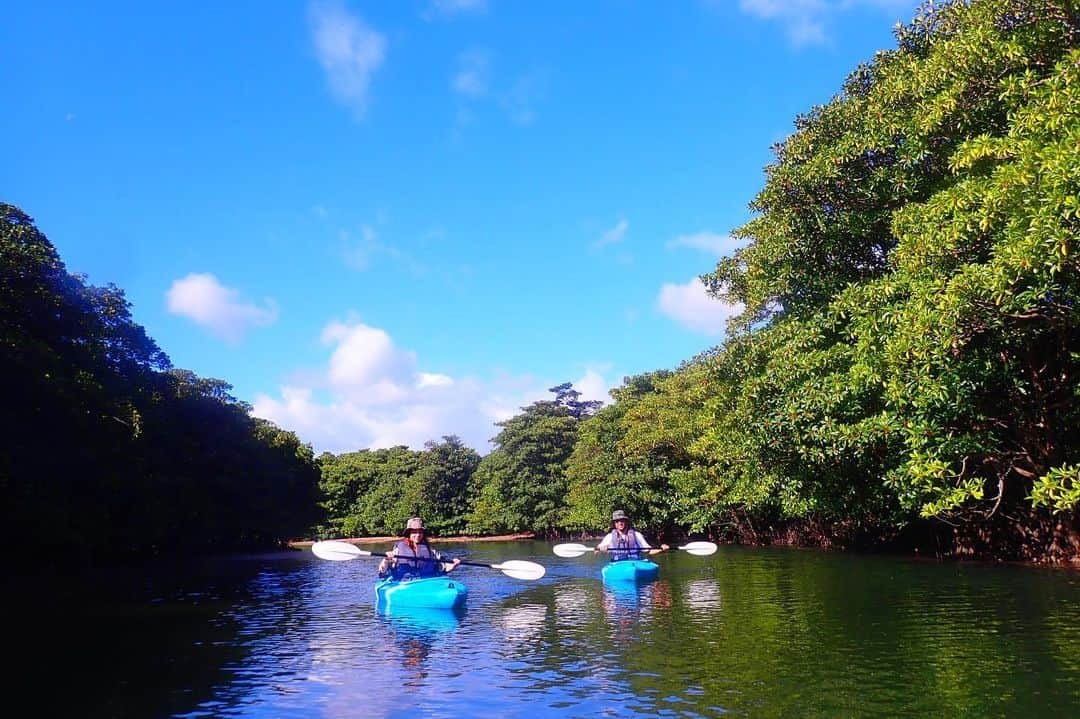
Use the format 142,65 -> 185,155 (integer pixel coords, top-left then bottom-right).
253,320 -> 610,453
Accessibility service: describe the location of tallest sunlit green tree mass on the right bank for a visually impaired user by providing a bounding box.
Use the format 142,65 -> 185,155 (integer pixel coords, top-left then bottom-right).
691,0 -> 1080,526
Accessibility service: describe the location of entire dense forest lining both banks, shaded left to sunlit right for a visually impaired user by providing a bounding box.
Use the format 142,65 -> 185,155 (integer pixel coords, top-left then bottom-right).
0,0 -> 1080,562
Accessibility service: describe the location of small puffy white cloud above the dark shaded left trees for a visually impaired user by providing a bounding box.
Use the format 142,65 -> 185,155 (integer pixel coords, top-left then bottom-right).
165,272 -> 278,343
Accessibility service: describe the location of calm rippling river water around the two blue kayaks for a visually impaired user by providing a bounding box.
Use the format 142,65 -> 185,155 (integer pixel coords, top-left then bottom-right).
16,542 -> 1080,719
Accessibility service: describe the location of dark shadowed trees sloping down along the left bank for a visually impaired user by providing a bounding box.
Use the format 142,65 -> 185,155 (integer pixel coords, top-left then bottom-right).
0,204 -> 318,561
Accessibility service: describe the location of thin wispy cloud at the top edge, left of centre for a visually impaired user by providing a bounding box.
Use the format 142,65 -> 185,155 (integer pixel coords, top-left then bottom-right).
309,0 -> 387,117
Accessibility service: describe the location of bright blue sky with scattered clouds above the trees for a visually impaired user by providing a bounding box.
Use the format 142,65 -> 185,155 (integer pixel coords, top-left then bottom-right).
6,0 -> 916,452
